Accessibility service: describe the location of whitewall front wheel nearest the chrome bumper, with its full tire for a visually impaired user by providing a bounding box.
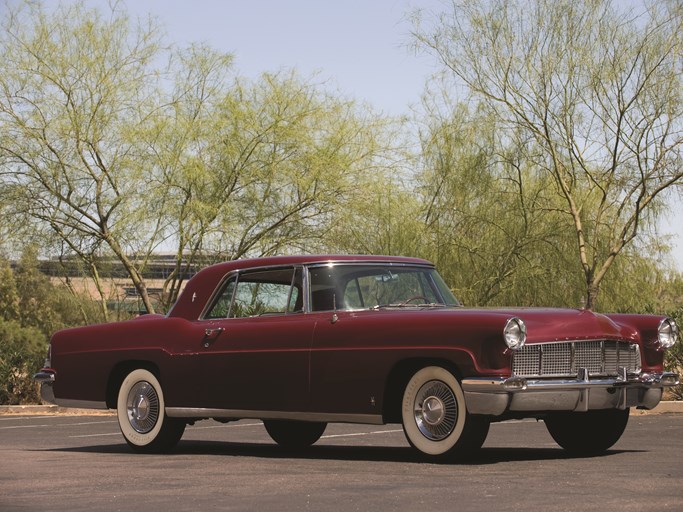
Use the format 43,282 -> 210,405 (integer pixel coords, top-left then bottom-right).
401,366 -> 490,457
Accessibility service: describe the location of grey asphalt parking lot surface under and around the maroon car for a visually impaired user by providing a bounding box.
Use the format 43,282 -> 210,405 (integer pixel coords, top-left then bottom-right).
0,414 -> 683,512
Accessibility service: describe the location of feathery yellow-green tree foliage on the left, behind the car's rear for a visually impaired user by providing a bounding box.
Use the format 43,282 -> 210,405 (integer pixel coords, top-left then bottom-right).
0,2 -> 398,314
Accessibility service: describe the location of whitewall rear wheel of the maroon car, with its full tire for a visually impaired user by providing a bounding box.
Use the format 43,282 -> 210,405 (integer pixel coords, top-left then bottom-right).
116,369 -> 185,453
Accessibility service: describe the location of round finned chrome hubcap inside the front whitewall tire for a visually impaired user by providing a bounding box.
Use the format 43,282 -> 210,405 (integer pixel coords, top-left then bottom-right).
414,380 -> 458,441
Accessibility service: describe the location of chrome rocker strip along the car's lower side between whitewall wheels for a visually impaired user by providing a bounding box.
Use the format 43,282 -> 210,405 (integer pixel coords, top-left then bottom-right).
166,407 -> 384,425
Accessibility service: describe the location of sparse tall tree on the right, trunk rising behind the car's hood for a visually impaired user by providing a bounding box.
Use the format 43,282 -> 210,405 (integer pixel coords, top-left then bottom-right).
415,0 -> 683,308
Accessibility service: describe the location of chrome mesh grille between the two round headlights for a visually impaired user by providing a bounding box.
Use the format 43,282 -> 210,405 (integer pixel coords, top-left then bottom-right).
512,341 -> 640,377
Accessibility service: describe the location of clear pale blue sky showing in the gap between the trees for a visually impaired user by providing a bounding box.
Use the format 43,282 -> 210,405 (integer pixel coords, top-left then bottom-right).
24,0 -> 683,271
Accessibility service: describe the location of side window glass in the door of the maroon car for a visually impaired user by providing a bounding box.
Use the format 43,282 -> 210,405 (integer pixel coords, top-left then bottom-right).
205,268 -> 303,319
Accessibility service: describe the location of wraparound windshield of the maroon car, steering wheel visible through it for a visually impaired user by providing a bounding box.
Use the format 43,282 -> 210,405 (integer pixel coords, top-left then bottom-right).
309,264 -> 459,311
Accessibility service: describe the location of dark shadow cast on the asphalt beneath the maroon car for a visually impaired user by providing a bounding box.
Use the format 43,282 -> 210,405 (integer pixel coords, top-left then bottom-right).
41,440 -> 642,465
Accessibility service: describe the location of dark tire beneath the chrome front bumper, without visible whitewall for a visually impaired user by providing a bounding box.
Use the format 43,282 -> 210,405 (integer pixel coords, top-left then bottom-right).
545,409 -> 629,455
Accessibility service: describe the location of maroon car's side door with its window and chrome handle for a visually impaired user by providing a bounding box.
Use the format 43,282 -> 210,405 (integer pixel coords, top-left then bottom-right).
194,267 -> 313,416
